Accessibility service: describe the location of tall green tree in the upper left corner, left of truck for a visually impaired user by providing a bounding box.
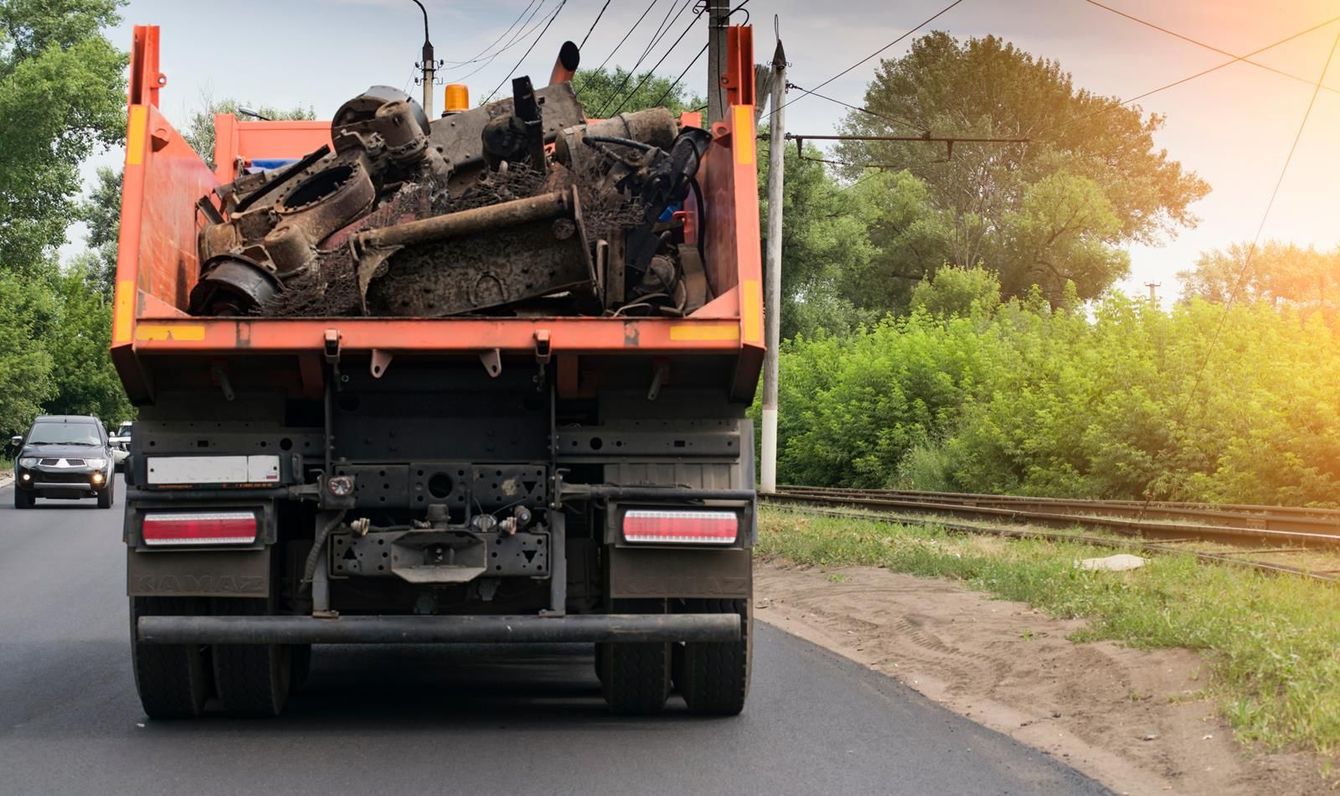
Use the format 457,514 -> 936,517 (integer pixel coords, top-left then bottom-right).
0,0 -> 126,276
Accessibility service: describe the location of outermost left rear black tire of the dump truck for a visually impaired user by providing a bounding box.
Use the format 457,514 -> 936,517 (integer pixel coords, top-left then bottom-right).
130,596 -> 212,721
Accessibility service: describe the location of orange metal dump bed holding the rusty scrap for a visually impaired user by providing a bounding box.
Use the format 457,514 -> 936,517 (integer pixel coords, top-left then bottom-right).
113,27 -> 764,402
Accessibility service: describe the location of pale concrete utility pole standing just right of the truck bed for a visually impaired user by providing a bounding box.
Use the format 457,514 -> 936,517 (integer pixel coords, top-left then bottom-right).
760,27 -> 787,494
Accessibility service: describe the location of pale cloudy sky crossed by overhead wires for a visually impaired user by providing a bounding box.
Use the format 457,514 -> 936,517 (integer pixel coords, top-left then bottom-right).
78,0 -> 1340,300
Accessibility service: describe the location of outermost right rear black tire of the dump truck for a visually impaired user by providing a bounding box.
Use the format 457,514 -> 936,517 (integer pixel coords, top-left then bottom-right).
675,600 -> 753,716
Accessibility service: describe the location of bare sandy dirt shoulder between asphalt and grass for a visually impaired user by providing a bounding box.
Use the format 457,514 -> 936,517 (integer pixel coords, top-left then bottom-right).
754,561 -> 1340,796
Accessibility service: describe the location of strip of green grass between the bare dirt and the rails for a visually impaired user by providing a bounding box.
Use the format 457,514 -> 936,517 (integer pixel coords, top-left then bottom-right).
757,508 -> 1340,754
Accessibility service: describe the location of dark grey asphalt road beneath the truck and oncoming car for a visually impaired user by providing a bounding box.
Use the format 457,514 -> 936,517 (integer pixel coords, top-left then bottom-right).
0,477 -> 1106,796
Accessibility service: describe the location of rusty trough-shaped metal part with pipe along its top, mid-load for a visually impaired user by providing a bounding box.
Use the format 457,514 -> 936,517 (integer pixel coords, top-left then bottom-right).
352,192 -> 598,318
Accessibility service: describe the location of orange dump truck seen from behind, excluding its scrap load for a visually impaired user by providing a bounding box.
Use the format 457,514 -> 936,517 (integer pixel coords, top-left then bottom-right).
111,27 -> 764,718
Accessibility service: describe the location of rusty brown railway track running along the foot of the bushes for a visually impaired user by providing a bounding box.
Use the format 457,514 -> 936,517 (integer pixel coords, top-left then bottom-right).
762,486 -> 1340,582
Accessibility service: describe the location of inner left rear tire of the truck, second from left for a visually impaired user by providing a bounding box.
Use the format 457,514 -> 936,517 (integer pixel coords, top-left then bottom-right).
212,599 -> 293,717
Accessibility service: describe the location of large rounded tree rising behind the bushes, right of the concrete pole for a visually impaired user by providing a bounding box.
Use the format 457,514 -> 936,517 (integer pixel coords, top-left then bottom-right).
838,32 -> 1209,302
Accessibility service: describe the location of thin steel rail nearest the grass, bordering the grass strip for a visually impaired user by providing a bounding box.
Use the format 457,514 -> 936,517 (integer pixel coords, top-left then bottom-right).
760,494 -> 1340,583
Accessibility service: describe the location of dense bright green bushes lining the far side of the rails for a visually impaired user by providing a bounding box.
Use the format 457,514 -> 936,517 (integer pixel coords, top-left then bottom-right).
779,269 -> 1340,504
